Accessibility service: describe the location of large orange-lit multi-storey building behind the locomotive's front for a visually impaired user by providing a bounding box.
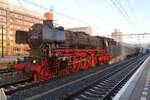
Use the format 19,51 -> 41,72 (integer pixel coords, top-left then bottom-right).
0,0 -> 44,55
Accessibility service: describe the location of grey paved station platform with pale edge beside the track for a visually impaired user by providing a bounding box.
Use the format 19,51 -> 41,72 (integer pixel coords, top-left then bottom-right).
113,56 -> 150,100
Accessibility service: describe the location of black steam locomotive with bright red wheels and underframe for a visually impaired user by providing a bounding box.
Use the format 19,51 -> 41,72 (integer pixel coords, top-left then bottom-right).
14,20 -> 116,81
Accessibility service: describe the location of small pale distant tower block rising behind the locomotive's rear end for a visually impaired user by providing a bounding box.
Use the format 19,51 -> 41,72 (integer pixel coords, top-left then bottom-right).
111,29 -> 122,42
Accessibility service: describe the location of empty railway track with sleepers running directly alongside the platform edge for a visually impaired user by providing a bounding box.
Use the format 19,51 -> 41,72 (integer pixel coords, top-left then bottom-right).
64,56 -> 146,100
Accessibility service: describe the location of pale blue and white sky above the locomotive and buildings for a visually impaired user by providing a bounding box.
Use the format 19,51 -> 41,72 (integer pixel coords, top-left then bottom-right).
8,0 -> 150,43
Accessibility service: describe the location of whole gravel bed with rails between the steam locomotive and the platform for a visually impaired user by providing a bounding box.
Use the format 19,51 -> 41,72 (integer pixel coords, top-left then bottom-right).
10,55 -> 148,100
